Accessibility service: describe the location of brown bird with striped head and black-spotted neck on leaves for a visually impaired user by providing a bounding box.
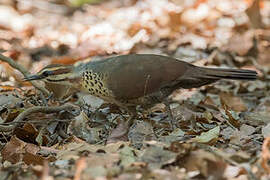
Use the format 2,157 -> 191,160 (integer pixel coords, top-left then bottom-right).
24,54 -> 257,129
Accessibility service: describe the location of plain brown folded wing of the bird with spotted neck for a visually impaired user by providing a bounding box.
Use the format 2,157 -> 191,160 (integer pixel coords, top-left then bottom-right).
104,54 -> 193,99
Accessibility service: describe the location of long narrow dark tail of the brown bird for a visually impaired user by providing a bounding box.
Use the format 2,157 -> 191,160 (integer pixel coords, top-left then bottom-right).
200,67 -> 257,80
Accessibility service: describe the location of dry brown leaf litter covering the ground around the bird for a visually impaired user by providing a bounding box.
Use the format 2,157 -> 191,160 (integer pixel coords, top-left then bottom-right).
0,0 -> 270,180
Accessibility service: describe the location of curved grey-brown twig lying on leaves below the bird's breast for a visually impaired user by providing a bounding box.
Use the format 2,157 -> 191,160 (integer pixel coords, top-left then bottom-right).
0,104 -> 77,132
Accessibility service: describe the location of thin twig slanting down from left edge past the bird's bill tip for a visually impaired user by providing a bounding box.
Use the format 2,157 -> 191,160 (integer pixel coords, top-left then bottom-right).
0,53 -> 50,96
